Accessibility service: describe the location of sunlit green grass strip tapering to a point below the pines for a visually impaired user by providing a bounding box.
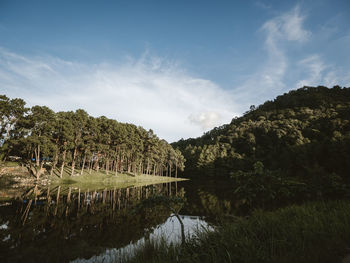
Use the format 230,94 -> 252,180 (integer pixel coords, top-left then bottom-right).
51,168 -> 186,193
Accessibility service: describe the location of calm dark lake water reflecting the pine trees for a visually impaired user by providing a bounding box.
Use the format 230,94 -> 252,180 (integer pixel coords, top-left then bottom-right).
0,181 -> 235,262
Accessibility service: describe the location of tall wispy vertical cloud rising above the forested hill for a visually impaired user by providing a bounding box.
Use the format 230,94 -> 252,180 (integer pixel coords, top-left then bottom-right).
231,6 -> 311,108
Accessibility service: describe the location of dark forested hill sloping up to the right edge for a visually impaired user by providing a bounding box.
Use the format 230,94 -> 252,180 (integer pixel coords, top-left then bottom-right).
172,86 -> 350,182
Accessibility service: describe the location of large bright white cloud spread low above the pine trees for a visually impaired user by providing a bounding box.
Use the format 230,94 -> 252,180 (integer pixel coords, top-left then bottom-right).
0,49 -> 236,141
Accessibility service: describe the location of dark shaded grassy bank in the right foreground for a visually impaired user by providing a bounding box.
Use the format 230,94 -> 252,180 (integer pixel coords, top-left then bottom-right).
121,201 -> 350,263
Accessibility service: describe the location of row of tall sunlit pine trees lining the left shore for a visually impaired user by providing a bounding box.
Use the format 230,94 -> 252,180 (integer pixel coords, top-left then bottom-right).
0,95 -> 185,177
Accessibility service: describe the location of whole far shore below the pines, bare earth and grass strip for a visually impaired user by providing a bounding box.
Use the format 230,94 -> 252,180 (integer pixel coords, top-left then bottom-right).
0,162 -> 188,199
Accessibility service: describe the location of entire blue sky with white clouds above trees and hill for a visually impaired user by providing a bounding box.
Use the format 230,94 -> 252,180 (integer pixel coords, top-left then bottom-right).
0,0 -> 350,142
